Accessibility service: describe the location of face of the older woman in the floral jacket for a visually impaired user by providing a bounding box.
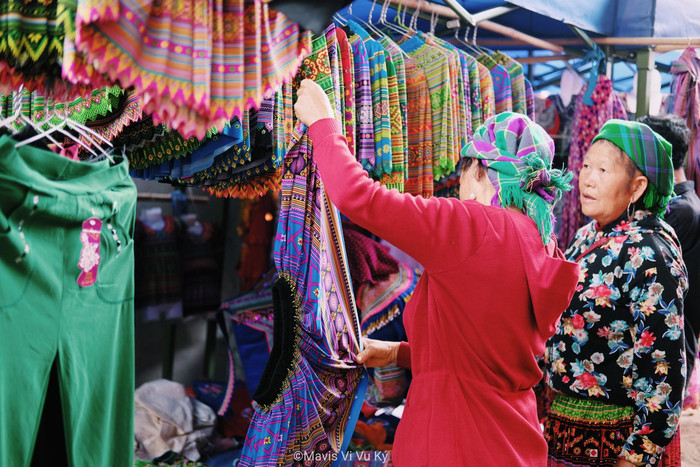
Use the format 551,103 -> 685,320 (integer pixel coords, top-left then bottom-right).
578,140 -> 636,226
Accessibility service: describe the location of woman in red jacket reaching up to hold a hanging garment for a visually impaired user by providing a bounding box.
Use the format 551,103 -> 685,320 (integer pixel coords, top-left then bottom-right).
295,80 -> 578,467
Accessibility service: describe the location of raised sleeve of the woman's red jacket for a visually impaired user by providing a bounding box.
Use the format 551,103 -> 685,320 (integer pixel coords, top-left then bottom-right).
309,118 -> 489,269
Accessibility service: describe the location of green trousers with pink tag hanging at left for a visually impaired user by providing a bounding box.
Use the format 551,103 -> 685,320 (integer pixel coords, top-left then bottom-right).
0,135 -> 136,467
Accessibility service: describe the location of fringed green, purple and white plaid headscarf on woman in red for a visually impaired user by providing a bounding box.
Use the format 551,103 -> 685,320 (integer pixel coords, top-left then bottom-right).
462,112 -> 573,245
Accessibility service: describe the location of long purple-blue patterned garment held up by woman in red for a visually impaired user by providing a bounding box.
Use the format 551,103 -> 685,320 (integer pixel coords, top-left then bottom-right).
240,31 -> 367,465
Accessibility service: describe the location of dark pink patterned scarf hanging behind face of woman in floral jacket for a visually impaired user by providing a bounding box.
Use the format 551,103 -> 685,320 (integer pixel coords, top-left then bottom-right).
559,75 -> 627,245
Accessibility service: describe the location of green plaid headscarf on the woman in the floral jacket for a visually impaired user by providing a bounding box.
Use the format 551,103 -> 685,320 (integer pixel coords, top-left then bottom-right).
593,119 -> 673,217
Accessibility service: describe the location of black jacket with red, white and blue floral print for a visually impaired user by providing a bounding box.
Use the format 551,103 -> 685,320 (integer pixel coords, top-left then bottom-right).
545,211 -> 688,463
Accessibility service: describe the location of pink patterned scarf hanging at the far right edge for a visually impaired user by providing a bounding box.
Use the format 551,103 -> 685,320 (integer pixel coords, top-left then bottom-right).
666,47 -> 700,194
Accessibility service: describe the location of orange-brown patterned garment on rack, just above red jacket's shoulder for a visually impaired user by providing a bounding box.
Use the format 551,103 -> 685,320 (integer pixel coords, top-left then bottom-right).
404,58 -> 433,198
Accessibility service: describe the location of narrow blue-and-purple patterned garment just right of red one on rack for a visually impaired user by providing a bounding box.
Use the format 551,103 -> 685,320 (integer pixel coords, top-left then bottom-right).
348,34 -> 376,173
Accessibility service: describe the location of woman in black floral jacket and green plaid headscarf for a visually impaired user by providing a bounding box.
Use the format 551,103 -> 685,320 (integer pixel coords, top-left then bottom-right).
545,120 -> 687,467
